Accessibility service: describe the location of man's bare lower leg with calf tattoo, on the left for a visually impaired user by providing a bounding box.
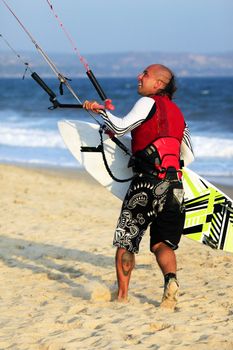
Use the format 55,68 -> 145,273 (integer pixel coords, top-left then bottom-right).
116,248 -> 135,301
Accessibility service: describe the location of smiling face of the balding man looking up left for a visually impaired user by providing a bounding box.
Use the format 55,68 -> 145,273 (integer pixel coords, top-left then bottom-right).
138,66 -> 158,96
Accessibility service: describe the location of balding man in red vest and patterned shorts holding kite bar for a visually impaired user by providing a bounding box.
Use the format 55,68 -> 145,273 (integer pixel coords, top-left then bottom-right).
84,64 -> 192,307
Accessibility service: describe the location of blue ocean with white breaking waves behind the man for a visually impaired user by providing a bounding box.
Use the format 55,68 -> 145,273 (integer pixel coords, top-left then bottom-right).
0,76 -> 233,185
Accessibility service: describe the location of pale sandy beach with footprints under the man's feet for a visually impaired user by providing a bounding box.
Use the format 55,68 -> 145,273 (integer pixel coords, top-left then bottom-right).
0,165 -> 233,350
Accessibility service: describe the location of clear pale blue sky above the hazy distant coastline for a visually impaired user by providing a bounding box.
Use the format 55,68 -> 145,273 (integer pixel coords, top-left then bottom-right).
0,0 -> 233,54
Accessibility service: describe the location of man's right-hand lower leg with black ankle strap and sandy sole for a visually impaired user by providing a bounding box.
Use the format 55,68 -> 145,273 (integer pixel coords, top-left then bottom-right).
151,242 -> 179,309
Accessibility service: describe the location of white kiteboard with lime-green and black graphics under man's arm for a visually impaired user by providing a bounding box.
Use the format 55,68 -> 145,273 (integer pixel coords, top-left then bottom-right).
58,120 -> 233,252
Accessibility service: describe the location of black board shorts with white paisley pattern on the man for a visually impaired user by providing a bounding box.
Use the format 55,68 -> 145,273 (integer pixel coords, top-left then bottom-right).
113,175 -> 185,253
